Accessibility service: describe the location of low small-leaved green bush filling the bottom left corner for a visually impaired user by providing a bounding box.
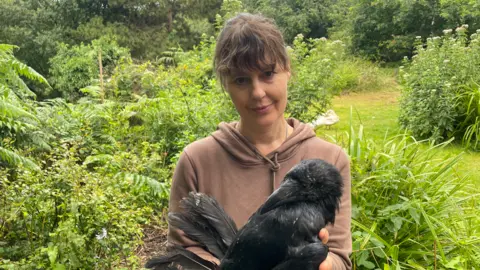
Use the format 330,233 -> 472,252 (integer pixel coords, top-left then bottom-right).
0,147 -> 152,269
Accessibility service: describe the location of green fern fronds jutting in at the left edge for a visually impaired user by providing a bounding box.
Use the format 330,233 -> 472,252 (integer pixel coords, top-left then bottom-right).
0,44 -> 50,170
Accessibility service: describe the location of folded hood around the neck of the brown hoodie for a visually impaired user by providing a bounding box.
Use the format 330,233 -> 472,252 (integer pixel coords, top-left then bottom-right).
212,118 -> 316,167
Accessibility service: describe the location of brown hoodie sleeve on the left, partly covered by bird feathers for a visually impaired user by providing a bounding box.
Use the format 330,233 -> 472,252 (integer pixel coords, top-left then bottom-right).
167,151 -> 215,261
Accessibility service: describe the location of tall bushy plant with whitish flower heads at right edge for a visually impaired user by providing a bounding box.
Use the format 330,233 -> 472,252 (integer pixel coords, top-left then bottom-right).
399,25 -> 480,149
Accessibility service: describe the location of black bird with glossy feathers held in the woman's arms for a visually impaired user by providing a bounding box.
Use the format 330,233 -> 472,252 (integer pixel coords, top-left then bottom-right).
146,159 -> 343,270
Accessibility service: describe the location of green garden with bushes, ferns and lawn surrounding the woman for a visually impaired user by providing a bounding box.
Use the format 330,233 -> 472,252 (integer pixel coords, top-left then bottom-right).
0,0 -> 480,269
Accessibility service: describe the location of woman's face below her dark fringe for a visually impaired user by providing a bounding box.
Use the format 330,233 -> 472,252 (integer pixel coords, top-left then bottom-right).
225,65 -> 290,130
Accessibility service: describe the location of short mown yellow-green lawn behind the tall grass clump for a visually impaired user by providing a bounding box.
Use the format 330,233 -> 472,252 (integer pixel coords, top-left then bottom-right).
317,88 -> 480,185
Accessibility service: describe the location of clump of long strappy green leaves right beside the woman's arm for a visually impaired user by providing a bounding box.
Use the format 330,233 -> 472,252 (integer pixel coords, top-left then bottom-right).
332,108 -> 480,269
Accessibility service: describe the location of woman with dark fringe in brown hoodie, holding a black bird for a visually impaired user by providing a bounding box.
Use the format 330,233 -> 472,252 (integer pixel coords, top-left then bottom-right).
168,14 -> 352,270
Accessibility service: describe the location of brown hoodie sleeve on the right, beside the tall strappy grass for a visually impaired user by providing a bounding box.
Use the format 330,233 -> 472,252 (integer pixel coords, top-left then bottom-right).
327,147 -> 352,270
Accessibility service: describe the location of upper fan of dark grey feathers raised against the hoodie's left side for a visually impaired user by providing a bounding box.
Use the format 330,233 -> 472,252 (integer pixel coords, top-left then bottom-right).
168,192 -> 238,260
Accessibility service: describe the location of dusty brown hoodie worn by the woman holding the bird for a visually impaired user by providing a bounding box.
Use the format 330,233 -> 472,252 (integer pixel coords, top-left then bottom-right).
168,119 -> 352,269
